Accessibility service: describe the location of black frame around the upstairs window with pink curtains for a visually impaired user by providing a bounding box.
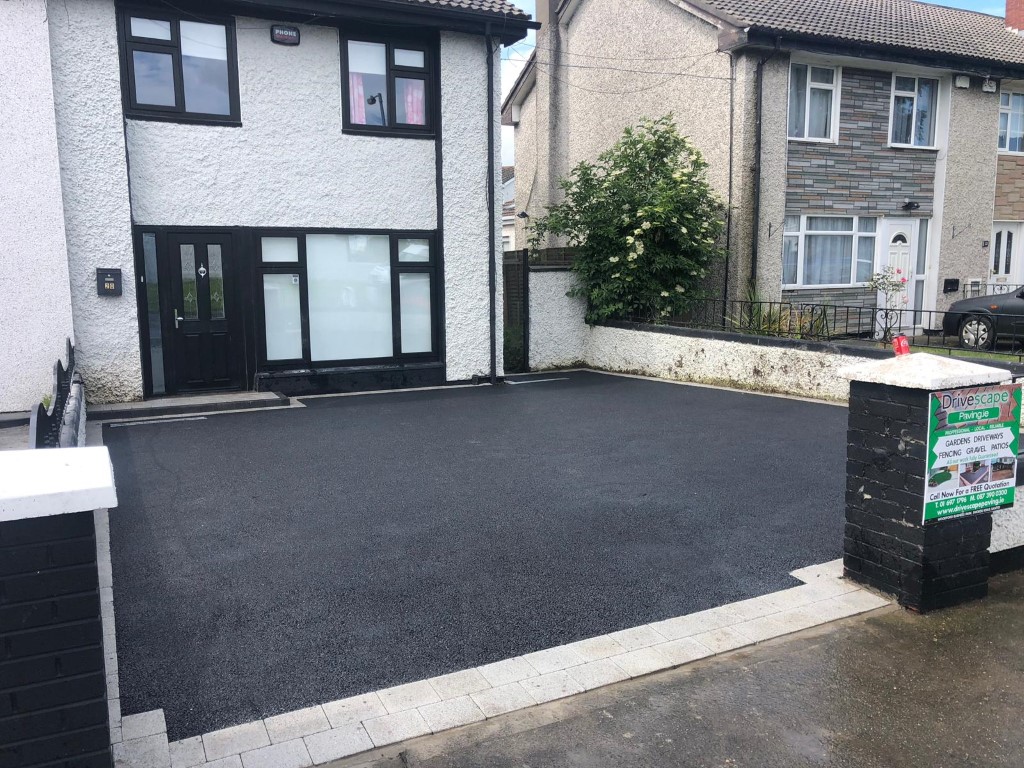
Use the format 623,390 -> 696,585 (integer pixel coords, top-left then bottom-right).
340,30 -> 441,138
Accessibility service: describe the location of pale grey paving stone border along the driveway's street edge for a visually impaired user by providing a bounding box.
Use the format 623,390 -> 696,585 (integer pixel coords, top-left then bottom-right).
112,560 -> 890,768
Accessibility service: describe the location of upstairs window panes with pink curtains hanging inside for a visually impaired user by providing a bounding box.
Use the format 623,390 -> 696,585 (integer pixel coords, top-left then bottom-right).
344,38 -> 433,134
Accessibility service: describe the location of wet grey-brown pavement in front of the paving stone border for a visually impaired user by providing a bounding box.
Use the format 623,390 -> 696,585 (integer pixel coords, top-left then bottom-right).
350,571 -> 1024,768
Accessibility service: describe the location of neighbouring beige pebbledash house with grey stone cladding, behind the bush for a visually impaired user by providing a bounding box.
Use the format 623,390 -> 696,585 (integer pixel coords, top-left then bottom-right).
503,0 -> 1024,328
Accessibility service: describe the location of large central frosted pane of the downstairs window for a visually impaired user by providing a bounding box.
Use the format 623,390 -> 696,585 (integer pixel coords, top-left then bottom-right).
306,234 -> 393,360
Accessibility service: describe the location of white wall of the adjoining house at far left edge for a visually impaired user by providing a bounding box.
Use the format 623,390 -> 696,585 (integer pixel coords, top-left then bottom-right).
0,0 -> 74,413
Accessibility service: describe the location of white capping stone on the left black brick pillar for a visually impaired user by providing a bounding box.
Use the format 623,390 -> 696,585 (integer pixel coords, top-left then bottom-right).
0,445 -> 118,522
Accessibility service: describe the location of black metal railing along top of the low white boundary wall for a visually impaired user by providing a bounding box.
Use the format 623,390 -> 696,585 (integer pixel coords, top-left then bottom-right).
634,299 -> 1024,361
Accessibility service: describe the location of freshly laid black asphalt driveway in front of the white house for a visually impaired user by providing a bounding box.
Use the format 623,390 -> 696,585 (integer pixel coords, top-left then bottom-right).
104,373 -> 847,740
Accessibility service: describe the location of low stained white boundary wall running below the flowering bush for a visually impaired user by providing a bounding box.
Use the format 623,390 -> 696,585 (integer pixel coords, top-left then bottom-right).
529,270 -> 1024,552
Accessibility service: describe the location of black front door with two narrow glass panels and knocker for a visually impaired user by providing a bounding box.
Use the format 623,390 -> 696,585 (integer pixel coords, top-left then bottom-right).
162,232 -> 244,392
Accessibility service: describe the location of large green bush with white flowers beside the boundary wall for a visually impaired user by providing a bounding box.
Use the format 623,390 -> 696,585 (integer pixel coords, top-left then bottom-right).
530,115 -> 725,324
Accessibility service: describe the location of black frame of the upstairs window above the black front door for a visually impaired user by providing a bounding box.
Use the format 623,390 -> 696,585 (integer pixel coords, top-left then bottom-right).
117,5 -> 242,126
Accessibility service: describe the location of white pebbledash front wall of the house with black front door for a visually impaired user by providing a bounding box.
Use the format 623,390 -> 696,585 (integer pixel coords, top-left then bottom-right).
41,0 -> 502,402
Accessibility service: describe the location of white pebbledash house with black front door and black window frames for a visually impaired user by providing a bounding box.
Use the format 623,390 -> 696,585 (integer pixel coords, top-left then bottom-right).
0,0 -> 536,412
